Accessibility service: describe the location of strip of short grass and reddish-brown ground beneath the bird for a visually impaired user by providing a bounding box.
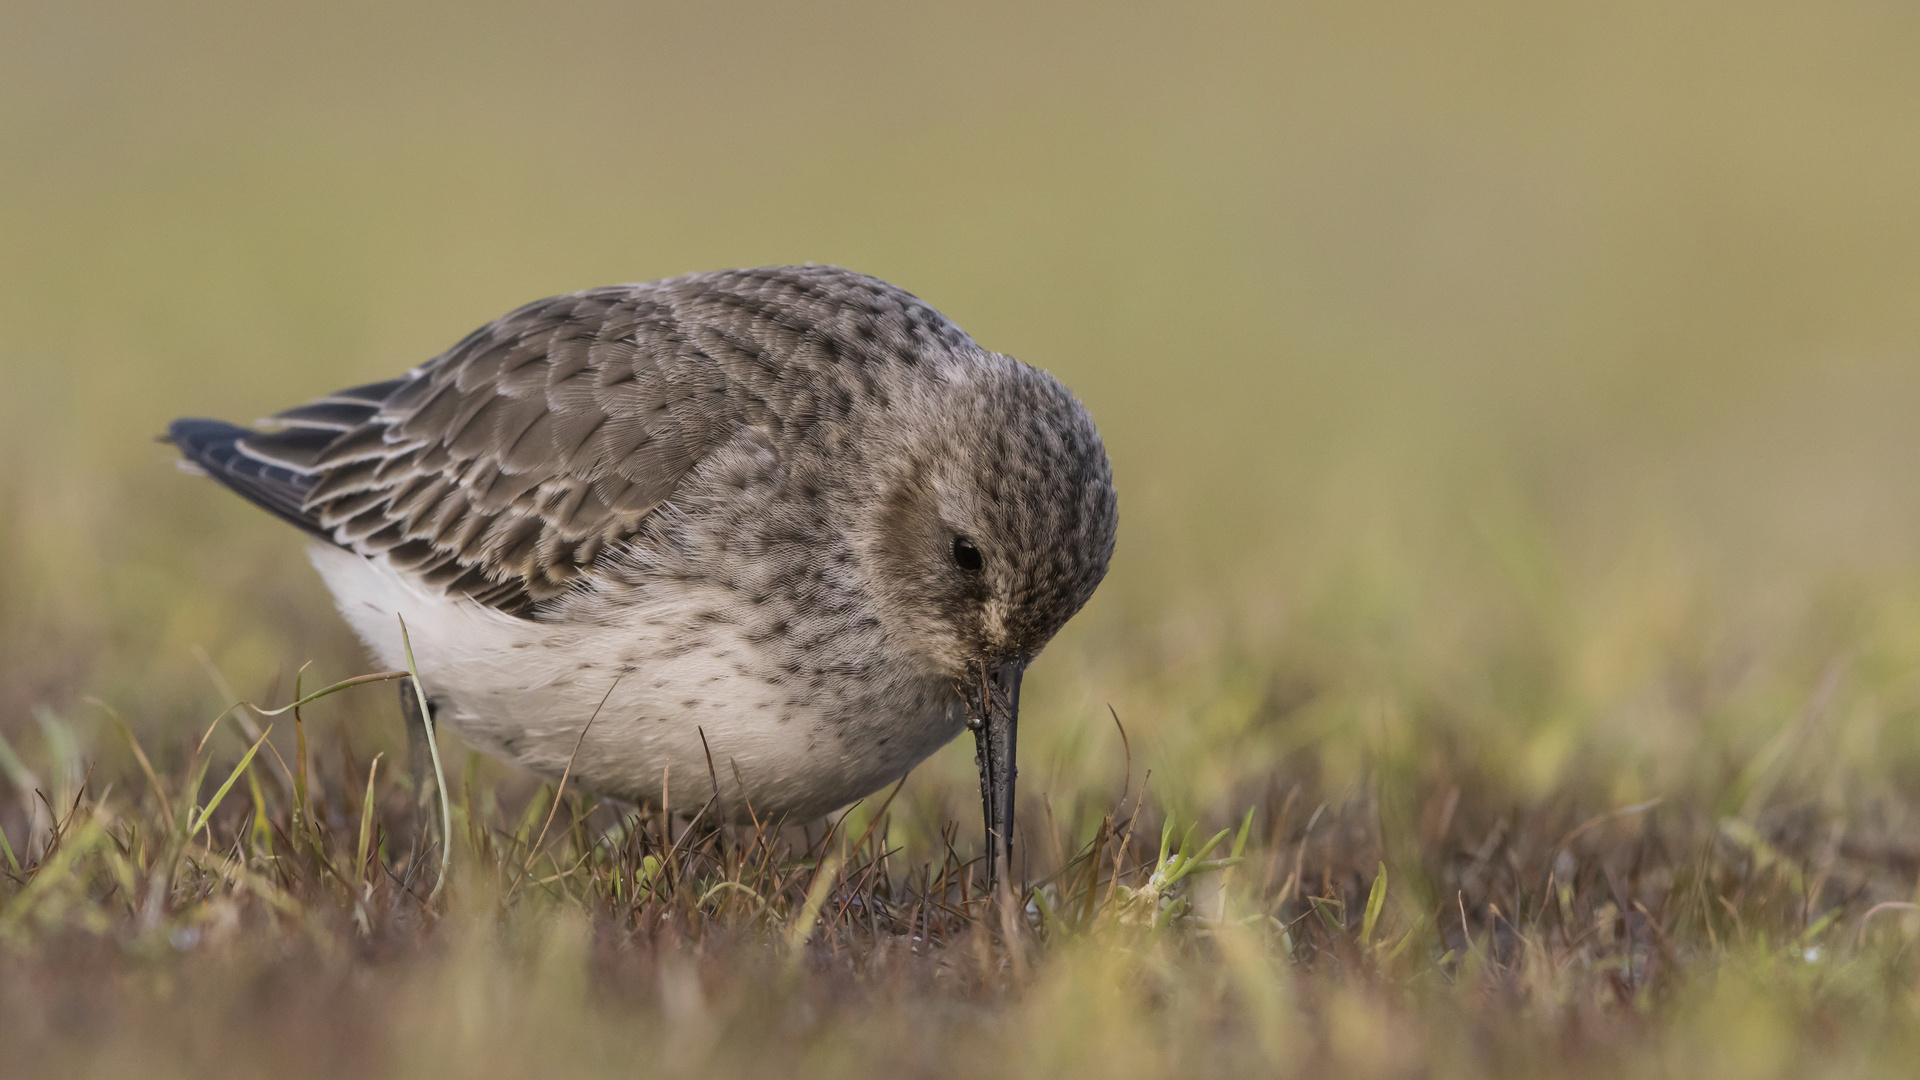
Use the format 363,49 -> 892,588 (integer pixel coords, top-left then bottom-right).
0,657 -> 1920,1076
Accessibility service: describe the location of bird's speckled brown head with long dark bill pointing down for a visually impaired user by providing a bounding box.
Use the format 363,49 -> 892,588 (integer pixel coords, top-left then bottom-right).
864,354 -> 1117,888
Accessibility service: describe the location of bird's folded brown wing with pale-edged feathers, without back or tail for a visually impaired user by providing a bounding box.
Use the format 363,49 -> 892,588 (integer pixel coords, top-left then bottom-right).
222,286 -> 732,615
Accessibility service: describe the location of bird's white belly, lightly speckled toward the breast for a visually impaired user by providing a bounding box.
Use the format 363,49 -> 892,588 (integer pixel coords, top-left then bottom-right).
309,544 -> 962,819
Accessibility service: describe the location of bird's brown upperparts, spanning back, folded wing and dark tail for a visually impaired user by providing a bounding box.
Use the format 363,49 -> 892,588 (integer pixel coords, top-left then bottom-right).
169,267 -> 975,615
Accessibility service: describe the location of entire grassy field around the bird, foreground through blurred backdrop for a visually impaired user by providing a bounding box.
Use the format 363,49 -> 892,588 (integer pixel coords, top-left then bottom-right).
0,0 -> 1920,1078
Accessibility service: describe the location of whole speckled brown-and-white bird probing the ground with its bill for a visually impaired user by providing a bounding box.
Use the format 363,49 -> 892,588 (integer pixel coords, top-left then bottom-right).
163,263 -> 1117,882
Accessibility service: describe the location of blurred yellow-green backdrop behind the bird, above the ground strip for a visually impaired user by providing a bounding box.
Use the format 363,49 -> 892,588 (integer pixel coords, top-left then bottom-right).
0,0 -> 1920,818
